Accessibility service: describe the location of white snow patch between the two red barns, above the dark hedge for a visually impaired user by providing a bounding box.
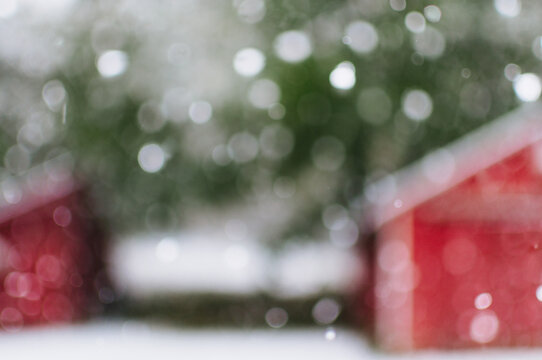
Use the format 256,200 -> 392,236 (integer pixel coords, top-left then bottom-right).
110,231 -> 363,298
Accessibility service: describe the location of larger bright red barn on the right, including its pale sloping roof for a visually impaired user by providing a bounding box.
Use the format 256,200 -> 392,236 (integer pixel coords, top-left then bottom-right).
365,104 -> 542,350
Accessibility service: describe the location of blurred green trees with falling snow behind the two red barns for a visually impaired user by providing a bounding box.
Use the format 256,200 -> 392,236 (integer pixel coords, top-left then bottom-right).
0,0 -> 542,246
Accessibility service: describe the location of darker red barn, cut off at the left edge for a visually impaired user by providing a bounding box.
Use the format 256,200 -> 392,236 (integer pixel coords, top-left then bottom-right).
0,160 -> 113,331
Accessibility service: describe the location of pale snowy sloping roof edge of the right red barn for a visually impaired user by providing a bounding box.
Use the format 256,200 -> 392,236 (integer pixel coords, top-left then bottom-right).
364,103 -> 542,228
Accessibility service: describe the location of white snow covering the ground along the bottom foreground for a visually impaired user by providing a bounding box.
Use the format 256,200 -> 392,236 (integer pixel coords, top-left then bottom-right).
0,321 -> 542,360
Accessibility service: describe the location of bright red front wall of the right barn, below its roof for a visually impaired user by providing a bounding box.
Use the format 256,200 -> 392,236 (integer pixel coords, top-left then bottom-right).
375,146 -> 542,349
